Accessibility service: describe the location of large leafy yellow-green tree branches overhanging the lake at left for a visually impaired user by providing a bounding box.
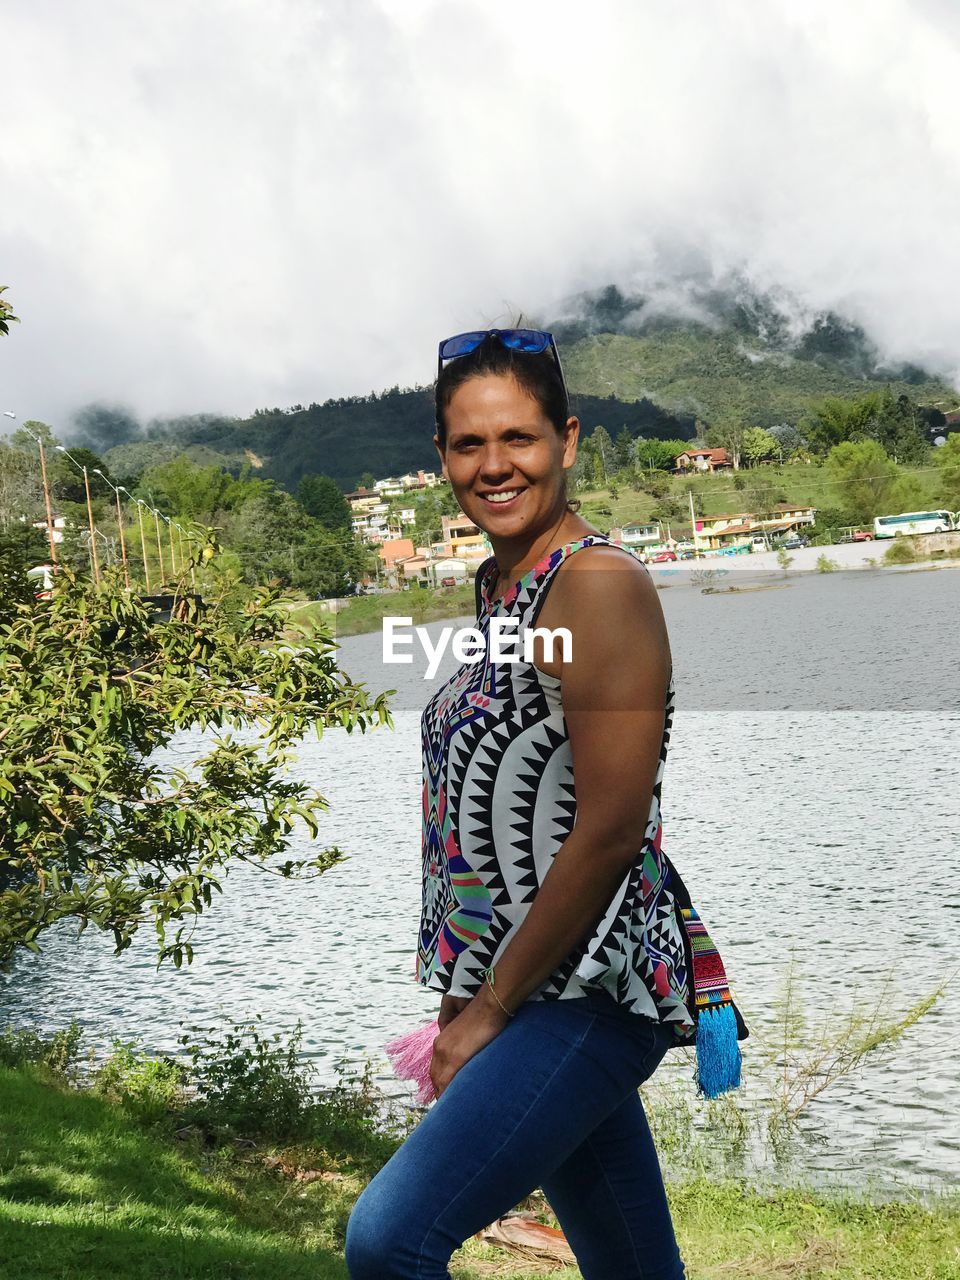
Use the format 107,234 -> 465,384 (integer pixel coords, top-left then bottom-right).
0,570 -> 389,965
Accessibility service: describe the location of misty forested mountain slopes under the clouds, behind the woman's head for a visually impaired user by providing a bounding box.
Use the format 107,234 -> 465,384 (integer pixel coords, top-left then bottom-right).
74,287 -> 957,492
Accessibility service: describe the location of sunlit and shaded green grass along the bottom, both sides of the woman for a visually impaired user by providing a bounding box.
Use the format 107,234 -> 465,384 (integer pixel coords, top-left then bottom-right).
0,1066 -> 960,1280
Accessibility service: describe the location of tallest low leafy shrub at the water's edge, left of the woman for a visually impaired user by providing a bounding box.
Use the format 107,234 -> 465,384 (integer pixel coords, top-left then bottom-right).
179,1015 -> 312,1139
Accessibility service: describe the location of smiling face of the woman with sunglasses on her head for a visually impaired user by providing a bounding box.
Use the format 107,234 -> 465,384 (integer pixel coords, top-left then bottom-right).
434,374 -> 580,539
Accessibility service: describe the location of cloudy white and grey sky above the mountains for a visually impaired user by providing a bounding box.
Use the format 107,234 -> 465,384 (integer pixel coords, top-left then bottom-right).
0,0 -> 960,424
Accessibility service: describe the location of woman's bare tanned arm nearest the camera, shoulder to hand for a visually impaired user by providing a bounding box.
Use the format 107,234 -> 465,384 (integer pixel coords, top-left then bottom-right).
430,548 -> 671,1094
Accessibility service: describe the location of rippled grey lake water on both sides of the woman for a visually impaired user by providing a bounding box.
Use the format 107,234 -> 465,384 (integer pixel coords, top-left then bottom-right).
0,568 -> 960,1187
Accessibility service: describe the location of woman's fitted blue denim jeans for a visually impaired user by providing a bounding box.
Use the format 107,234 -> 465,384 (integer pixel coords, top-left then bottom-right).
347,991 -> 686,1280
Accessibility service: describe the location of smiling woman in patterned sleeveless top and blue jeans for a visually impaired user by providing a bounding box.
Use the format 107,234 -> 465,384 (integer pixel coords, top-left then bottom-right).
347,330 -> 742,1280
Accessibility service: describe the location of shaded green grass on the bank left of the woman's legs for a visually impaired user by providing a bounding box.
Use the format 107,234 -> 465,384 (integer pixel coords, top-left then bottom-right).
0,1068 -> 358,1280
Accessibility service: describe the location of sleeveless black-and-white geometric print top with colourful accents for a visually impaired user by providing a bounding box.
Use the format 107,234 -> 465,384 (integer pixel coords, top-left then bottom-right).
416,535 -> 695,1042
